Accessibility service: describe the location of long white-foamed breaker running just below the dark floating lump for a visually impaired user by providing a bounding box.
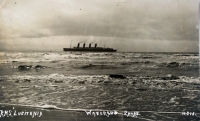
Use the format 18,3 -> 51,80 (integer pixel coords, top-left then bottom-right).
0,74 -> 200,90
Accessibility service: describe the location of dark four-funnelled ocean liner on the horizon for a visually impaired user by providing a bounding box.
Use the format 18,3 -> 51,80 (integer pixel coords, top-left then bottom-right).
63,43 -> 117,52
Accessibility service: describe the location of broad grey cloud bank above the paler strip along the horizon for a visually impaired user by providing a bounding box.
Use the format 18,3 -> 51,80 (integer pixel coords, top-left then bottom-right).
0,0 -> 198,40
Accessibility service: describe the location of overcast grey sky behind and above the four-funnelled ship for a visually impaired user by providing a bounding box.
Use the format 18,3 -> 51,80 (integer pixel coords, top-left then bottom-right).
0,0 -> 198,52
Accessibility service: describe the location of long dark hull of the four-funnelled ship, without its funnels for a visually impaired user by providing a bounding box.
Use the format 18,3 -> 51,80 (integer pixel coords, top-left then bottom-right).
63,48 -> 117,52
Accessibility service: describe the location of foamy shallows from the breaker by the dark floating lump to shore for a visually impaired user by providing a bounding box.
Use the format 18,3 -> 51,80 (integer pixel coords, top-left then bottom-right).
0,73 -> 200,117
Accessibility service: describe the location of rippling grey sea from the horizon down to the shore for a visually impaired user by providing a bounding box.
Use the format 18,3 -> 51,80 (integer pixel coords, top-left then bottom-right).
0,52 -> 200,121
